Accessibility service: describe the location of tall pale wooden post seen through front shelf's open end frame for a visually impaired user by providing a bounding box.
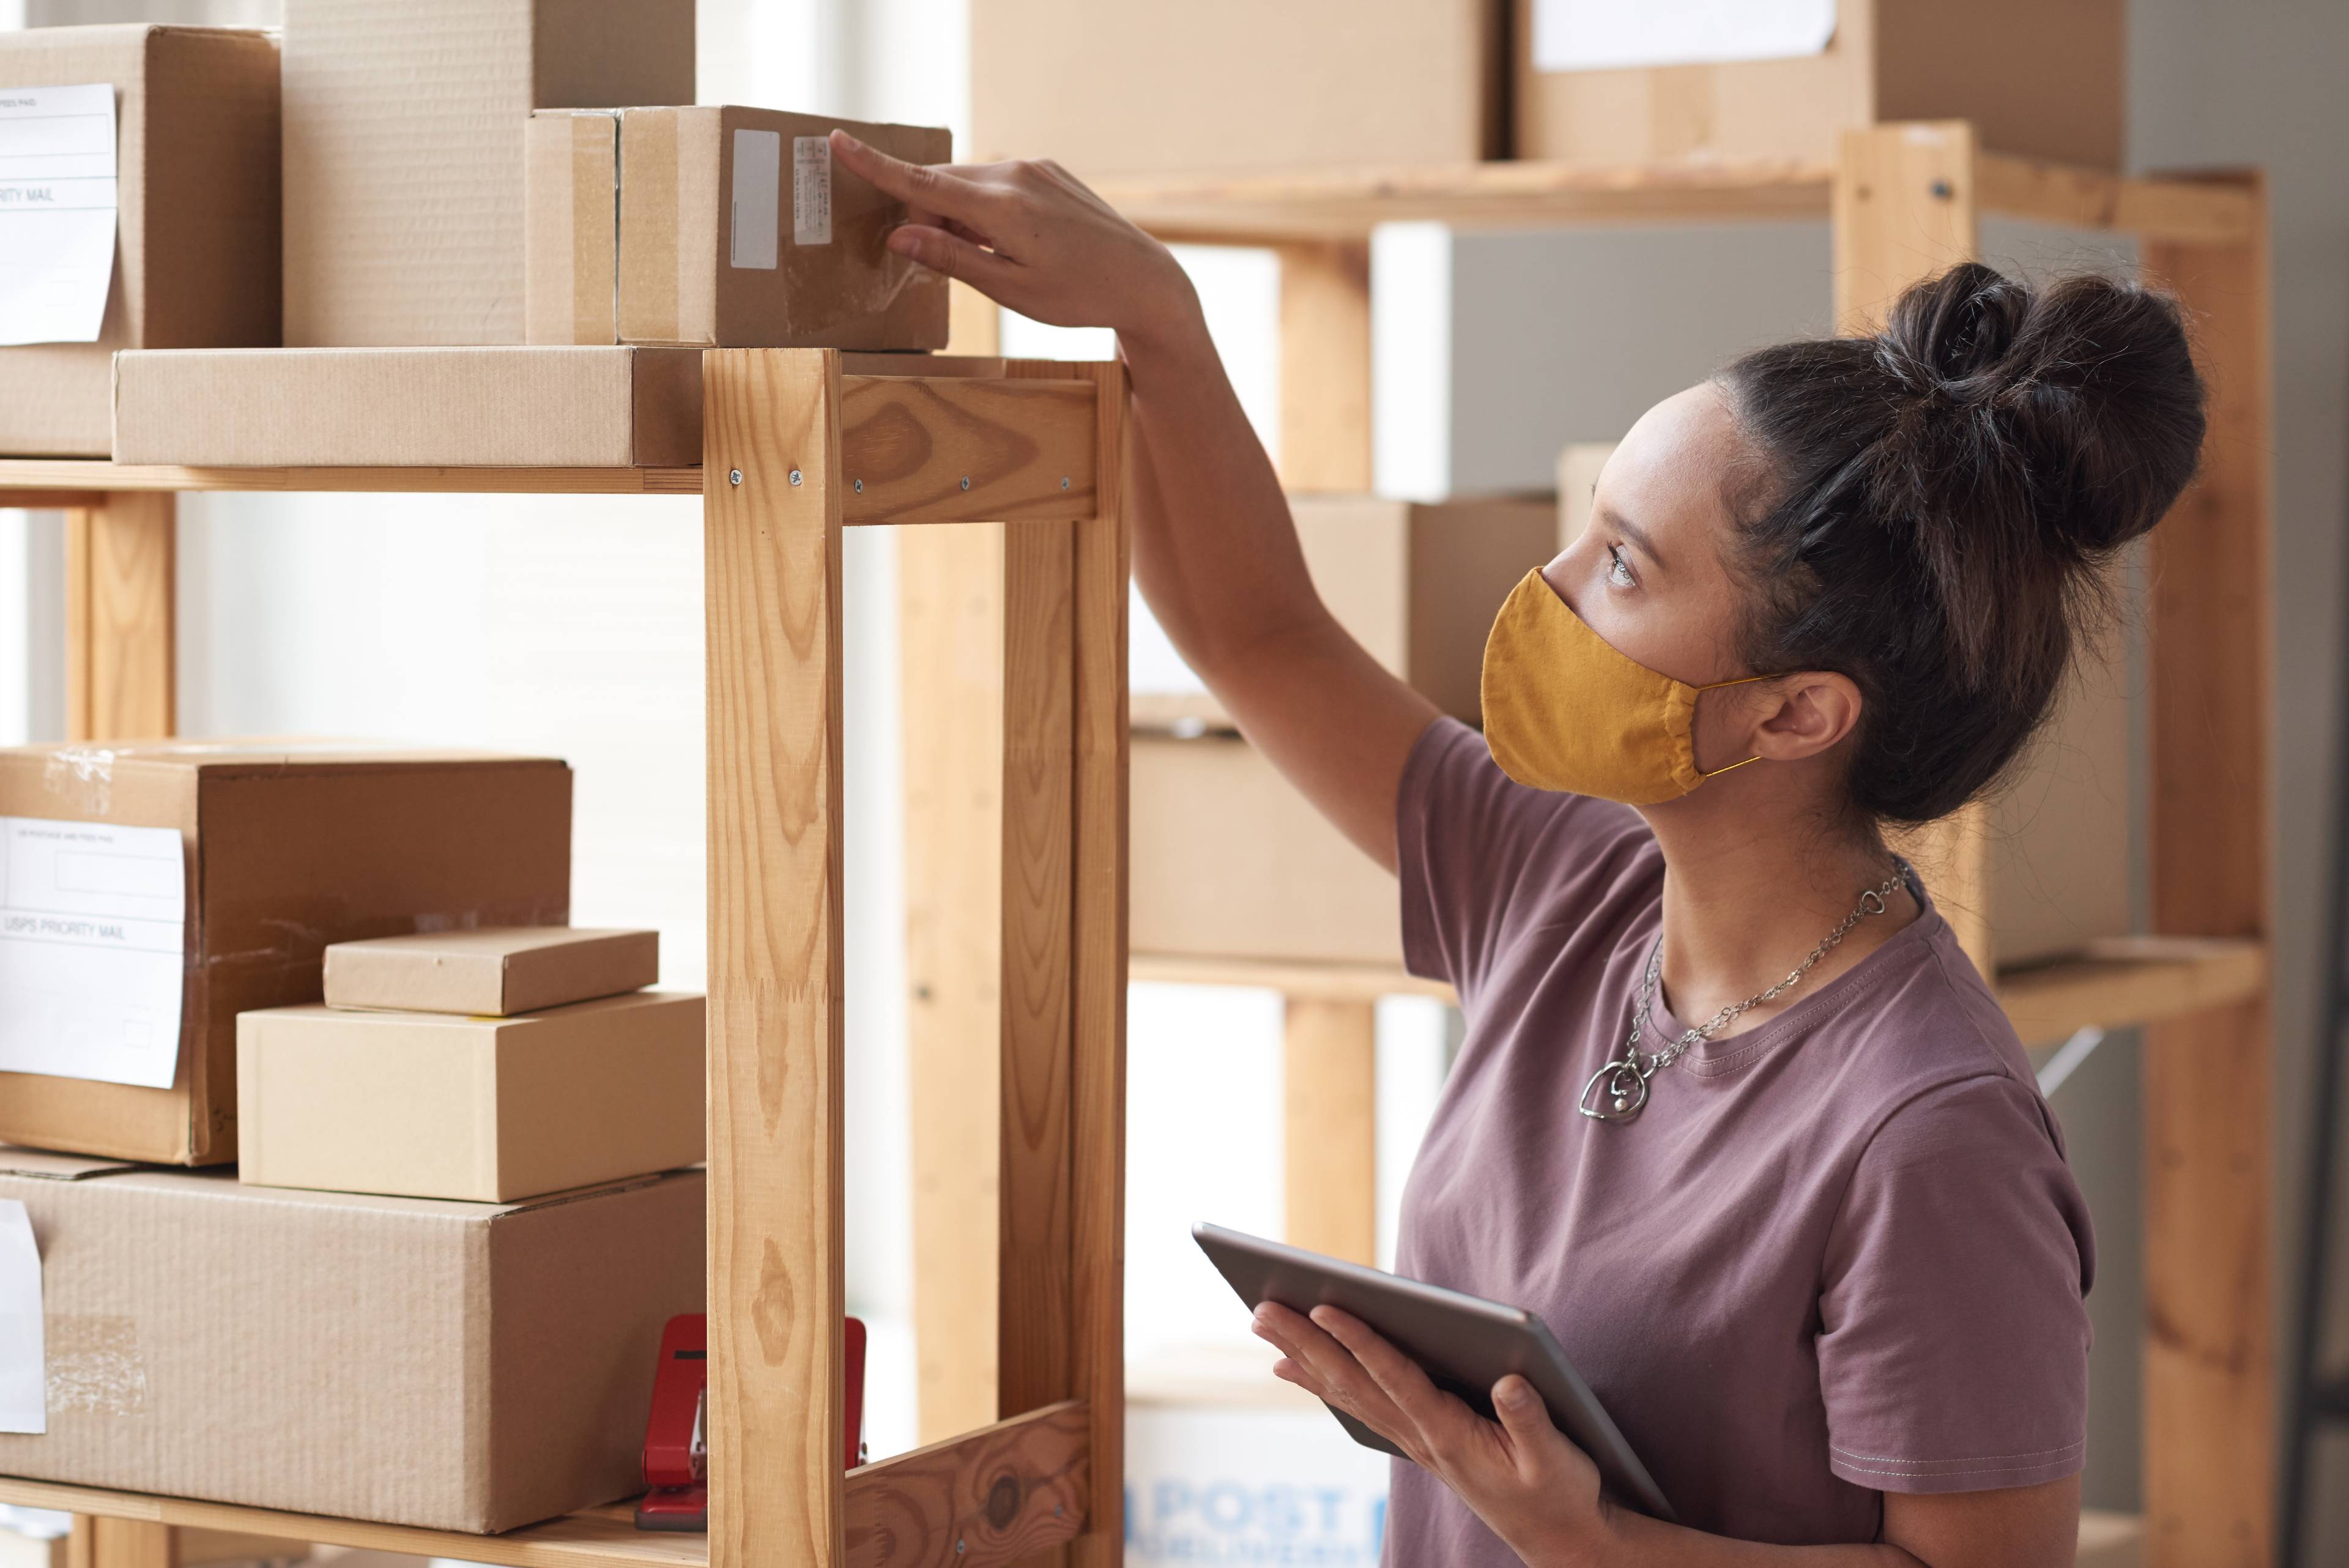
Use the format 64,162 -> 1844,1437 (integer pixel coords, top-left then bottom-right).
897,522 -> 1003,1443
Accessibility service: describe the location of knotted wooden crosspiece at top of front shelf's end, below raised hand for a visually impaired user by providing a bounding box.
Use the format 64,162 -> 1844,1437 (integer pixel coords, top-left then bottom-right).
841,381 -> 1094,524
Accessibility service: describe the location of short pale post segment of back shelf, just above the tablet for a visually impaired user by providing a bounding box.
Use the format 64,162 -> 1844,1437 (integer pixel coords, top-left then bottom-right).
1280,997 -> 1379,1265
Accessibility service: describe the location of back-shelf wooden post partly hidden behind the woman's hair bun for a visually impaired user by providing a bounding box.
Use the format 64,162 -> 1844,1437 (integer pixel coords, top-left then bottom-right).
1830,120 -> 1999,978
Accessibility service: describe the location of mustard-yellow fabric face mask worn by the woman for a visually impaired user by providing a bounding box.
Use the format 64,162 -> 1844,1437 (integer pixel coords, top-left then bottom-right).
1482,571 -> 1764,806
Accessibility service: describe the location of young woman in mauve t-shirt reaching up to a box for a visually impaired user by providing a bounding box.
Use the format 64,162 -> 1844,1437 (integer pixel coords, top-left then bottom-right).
836,139 -> 2203,1568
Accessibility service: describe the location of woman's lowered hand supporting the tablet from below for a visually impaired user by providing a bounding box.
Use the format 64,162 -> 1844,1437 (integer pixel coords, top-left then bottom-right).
1252,1302 -> 1614,1568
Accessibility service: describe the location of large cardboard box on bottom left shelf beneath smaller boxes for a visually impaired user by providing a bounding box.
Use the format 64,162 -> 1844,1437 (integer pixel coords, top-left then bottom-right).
0,1152 -> 707,1533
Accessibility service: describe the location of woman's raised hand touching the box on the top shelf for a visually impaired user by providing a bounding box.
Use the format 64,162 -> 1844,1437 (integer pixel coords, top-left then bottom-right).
831,132 -> 1198,355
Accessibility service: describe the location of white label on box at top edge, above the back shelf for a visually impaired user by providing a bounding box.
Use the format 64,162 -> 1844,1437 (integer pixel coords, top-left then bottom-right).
1534,0 -> 1835,70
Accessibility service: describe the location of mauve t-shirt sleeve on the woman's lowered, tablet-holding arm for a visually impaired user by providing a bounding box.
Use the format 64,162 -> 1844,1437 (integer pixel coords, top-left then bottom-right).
1818,1074 -> 2095,1493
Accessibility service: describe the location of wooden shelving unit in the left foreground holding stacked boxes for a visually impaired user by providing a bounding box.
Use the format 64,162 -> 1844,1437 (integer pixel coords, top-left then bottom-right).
0,351 -> 1127,1568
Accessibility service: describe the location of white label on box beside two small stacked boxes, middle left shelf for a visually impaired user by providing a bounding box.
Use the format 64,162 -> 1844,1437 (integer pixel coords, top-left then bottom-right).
0,816 -> 188,1088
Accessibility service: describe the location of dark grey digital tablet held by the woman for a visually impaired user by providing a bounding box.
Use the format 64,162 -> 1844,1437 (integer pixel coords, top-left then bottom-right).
1191,1225 -> 1672,1518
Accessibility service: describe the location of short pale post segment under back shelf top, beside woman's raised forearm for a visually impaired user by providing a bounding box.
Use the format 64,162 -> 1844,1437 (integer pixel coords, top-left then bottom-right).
1280,240 -> 1370,494
